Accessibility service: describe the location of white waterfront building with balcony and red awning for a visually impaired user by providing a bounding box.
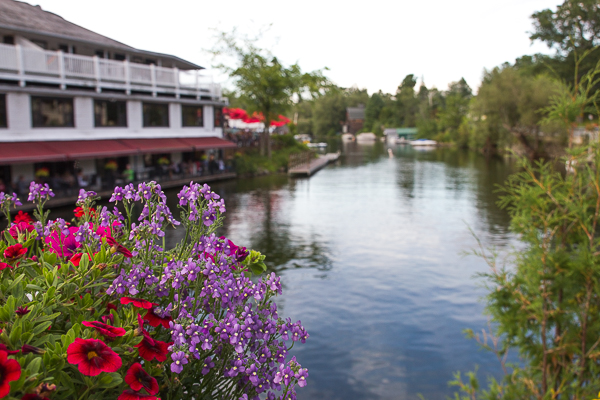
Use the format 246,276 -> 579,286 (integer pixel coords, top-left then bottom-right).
0,0 -> 235,194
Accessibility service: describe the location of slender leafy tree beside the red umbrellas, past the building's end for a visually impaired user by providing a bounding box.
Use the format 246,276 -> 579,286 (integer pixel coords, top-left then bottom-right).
212,32 -> 328,158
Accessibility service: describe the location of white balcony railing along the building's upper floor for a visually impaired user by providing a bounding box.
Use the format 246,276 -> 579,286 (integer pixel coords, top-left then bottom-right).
0,44 -> 221,100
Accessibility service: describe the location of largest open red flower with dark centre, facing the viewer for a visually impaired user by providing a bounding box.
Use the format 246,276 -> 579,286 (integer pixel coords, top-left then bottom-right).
67,338 -> 123,376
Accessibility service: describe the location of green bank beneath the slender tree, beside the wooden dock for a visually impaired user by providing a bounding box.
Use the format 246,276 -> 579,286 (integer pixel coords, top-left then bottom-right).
234,135 -> 309,176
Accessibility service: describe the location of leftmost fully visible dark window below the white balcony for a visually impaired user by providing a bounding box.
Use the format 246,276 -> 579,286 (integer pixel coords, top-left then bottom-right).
31,97 -> 74,128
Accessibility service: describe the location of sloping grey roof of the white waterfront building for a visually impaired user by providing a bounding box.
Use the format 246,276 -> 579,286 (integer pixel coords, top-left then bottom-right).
0,0 -> 202,69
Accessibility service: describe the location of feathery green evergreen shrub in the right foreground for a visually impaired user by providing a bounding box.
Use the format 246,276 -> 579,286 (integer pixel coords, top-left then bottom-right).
455,144 -> 600,400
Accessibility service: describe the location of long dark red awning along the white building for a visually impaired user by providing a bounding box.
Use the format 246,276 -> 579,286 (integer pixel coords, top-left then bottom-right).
0,137 -> 236,165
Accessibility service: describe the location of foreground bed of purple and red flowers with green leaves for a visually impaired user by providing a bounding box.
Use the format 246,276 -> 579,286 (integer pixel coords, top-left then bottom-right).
0,182 -> 308,400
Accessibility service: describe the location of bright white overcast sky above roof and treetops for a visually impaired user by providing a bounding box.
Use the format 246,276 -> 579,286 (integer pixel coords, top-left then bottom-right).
31,0 -> 561,93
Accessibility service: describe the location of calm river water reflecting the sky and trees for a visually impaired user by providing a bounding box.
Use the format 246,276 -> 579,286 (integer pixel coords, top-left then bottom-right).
199,144 -> 517,399
